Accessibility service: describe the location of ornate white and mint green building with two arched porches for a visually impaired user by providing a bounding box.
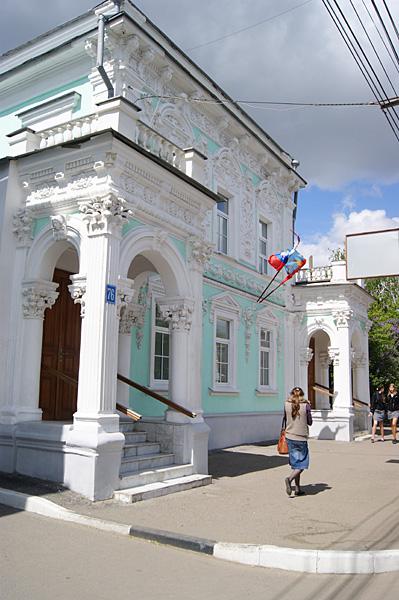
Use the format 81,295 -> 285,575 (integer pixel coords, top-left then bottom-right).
0,0 -> 376,501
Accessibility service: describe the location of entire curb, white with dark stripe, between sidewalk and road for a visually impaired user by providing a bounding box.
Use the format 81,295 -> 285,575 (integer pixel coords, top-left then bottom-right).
0,488 -> 399,574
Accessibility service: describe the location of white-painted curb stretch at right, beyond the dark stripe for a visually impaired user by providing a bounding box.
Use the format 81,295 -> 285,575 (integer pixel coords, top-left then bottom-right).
213,542 -> 399,574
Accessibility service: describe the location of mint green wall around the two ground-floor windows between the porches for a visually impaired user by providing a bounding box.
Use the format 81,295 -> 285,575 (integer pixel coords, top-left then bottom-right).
201,284 -> 284,414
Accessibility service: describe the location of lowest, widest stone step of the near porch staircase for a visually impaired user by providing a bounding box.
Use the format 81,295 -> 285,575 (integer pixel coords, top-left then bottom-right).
114,474 -> 212,504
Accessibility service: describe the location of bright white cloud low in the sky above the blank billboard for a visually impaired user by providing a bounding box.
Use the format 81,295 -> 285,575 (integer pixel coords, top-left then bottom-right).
299,209 -> 399,266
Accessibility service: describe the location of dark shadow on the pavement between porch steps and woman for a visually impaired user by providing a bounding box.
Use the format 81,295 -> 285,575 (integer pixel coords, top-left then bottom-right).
209,450 -> 288,479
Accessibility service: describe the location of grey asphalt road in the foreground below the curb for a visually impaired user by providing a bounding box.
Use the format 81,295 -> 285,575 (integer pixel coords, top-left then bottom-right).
0,505 -> 399,600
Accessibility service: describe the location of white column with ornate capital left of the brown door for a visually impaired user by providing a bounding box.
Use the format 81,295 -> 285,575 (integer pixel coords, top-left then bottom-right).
16,279 -> 58,421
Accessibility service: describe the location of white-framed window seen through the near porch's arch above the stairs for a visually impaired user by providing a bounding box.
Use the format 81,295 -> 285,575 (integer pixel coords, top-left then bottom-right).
150,301 -> 170,388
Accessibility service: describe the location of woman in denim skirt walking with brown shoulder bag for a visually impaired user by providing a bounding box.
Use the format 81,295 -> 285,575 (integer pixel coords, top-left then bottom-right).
284,387 -> 312,496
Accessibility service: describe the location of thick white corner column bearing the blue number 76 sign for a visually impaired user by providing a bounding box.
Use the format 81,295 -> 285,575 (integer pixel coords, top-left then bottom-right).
65,194 -> 133,500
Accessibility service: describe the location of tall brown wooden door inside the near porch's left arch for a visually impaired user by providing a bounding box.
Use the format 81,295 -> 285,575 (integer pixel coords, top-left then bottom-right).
39,269 -> 81,421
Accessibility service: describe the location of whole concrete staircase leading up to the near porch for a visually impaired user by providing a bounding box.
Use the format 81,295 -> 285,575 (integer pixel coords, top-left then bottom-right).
114,418 -> 212,503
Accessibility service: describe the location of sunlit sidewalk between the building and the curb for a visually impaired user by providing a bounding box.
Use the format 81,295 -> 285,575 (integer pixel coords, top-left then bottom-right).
0,438 -> 399,550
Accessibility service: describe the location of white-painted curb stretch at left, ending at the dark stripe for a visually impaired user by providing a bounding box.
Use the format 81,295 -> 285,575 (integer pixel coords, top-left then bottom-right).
0,488 -> 130,535
